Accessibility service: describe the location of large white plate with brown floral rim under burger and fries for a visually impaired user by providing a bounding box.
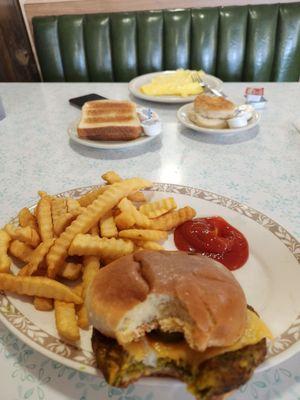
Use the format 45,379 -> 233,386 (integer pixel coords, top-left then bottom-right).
0,183 -> 300,399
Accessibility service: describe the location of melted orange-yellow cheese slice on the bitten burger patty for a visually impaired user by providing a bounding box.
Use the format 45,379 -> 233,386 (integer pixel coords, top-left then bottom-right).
124,310 -> 272,367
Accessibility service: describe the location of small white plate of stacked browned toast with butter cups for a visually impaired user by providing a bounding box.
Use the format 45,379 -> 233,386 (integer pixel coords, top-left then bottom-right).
68,100 -> 161,149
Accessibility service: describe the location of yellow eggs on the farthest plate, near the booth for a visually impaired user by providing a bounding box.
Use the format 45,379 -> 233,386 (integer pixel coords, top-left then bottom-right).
140,70 -> 203,97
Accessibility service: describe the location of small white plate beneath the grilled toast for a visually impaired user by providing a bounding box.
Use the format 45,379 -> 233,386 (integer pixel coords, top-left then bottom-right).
68,120 -> 157,149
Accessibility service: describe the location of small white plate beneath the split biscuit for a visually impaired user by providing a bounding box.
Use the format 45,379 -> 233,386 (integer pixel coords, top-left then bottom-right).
177,103 -> 260,135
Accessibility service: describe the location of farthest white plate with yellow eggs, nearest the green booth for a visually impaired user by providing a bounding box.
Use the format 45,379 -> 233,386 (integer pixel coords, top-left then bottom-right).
129,69 -> 223,103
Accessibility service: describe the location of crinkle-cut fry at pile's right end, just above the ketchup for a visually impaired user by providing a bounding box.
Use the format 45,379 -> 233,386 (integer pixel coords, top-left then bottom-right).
151,206 -> 196,231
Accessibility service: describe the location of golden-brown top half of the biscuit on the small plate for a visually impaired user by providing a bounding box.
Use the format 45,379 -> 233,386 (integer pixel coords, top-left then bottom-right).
194,94 -> 236,119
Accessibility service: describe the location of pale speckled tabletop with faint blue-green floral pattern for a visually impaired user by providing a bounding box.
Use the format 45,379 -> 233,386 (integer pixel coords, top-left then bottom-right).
0,83 -> 300,400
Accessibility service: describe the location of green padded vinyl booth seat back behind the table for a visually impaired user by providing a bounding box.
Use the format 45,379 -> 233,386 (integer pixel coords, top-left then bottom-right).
33,3 -> 300,82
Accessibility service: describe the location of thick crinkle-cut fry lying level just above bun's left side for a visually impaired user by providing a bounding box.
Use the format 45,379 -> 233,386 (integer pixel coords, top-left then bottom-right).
69,233 -> 134,260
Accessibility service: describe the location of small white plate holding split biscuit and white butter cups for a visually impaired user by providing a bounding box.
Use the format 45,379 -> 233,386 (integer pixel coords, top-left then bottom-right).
177,93 -> 260,135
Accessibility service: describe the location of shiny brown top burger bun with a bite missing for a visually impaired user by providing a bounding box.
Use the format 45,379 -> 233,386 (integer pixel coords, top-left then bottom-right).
86,250 -> 247,351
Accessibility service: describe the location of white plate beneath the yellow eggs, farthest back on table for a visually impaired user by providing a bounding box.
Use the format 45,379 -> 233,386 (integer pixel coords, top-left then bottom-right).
128,71 -> 223,103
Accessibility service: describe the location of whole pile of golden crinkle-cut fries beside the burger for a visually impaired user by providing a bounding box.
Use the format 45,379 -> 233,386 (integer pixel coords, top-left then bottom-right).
0,171 -> 196,343
